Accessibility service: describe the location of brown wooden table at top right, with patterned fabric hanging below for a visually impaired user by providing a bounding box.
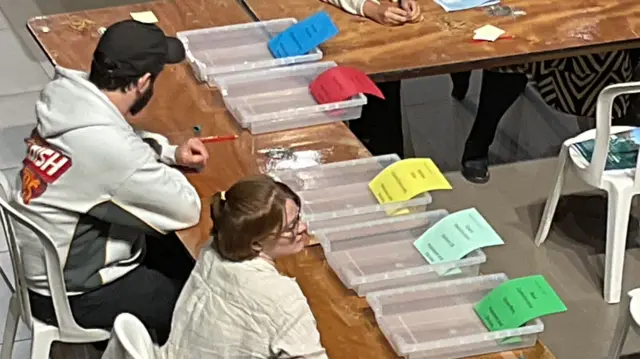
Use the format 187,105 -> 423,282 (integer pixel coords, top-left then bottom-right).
242,0 -> 640,81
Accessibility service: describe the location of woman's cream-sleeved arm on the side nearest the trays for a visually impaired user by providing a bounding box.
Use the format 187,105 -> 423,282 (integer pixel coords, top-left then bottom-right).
270,289 -> 328,359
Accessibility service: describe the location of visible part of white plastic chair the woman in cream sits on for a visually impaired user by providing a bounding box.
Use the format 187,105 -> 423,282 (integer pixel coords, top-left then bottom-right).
102,313 -> 156,359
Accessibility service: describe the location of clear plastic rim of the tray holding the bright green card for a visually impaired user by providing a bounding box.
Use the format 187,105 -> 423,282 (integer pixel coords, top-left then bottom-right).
367,273 -> 544,355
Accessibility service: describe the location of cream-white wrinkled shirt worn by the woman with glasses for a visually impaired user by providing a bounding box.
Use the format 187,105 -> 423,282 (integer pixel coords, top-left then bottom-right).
156,246 -> 327,359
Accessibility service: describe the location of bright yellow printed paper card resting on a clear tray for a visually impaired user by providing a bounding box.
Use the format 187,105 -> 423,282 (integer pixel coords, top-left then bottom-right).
369,158 -> 451,204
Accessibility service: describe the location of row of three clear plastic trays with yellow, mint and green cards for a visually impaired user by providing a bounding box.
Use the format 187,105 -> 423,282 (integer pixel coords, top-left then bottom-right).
274,155 -> 544,359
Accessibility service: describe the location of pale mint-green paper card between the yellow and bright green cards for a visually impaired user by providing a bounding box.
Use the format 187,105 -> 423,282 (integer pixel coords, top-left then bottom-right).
413,208 -> 504,275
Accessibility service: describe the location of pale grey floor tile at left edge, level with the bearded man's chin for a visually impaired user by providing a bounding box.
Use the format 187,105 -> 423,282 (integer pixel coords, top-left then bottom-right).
0,91 -> 40,129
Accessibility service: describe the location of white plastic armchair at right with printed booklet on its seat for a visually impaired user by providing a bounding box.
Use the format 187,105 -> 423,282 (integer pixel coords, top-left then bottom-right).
535,82 -> 640,304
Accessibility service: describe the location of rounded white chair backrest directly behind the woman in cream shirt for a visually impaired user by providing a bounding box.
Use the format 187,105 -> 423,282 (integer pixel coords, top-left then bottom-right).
113,313 -> 155,359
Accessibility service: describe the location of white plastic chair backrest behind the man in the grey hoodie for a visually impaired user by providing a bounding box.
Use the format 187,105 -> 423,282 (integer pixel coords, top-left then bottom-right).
0,172 -> 109,341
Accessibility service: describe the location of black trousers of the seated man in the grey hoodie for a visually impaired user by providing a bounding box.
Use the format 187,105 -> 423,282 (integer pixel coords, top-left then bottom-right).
29,234 -> 195,345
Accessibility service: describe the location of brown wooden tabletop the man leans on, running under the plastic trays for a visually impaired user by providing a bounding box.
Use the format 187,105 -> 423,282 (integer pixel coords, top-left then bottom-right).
28,0 -> 555,359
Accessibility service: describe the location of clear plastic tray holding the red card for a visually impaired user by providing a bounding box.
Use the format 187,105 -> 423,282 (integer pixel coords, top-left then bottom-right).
216,62 -> 367,134
